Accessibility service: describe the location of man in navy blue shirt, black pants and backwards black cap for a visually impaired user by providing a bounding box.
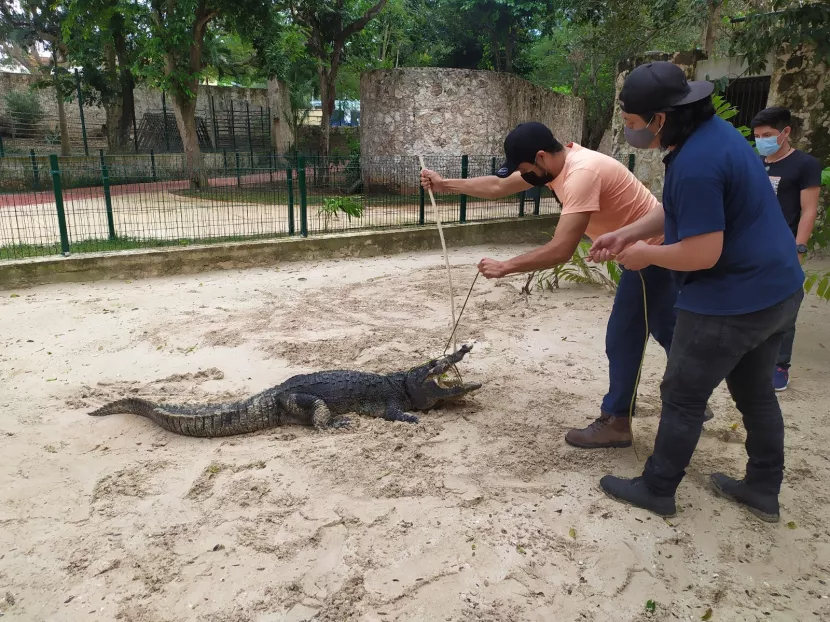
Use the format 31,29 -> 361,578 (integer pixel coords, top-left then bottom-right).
591,62 -> 804,522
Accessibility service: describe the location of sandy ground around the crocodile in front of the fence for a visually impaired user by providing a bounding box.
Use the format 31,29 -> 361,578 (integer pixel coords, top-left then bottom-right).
0,246 -> 830,622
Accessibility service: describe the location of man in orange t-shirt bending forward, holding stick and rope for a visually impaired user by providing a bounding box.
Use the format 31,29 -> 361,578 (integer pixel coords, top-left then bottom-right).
421,122 -> 712,449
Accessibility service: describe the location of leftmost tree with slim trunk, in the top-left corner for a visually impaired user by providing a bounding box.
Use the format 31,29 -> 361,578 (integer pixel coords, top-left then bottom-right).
0,0 -> 73,156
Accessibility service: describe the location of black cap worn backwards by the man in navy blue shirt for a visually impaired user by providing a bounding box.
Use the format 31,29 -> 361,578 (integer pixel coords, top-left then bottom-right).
620,61 -> 715,114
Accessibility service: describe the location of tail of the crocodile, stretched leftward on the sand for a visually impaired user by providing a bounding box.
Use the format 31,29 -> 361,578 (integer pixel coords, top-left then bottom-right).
89,398 -> 280,438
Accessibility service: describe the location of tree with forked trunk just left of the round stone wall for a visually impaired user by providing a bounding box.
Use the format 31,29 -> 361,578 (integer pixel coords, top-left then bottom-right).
275,0 -> 387,156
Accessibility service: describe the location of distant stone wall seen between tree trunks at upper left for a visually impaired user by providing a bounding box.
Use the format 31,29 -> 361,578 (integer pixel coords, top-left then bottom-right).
0,72 -> 291,151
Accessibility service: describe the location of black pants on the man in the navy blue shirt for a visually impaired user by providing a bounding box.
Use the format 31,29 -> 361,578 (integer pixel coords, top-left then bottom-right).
643,289 -> 804,496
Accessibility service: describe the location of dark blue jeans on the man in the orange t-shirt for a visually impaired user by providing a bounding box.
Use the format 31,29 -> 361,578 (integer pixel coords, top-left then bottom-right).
601,266 -> 677,417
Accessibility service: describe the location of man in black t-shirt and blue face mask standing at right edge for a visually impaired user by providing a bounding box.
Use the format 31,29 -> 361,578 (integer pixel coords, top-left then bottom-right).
751,106 -> 821,391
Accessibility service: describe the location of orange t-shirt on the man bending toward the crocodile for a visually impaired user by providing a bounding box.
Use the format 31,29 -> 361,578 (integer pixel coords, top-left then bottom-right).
548,143 -> 663,244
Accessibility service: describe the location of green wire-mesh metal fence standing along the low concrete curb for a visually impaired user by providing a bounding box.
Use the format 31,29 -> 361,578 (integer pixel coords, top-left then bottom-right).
0,151 -> 633,260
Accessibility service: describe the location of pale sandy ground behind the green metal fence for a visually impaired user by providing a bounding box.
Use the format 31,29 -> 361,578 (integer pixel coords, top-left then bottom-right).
0,186 -> 559,246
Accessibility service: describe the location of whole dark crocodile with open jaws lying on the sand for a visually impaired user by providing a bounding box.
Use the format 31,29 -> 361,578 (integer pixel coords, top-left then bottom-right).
89,345 -> 481,438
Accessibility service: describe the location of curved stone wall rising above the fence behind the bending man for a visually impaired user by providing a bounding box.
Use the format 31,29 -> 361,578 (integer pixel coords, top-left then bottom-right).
360,68 -> 584,158
